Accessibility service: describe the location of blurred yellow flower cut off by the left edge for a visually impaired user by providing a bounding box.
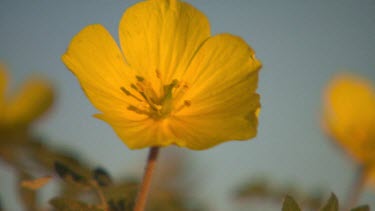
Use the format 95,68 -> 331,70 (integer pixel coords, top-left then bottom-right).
0,64 -> 54,130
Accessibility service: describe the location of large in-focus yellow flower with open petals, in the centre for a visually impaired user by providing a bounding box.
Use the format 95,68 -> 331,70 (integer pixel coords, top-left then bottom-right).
62,0 -> 261,150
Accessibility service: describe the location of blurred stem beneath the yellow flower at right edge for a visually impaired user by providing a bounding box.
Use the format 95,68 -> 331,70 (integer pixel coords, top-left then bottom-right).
345,166 -> 366,210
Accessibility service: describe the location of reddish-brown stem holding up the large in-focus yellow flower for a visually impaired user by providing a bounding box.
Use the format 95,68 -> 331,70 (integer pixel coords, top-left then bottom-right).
134,147 -> 159,211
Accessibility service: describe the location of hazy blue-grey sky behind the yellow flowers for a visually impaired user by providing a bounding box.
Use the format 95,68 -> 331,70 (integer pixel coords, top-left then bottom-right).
0,0 -> 375,211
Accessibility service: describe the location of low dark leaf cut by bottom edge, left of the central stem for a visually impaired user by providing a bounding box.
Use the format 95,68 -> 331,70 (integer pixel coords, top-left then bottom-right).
49,197 -> 101,211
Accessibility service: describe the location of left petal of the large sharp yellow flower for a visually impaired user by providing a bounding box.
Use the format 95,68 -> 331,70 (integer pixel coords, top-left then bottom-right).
62,24 -> 143,119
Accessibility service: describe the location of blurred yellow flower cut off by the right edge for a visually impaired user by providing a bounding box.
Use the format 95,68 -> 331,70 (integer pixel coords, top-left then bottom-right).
324,75 -> 375,167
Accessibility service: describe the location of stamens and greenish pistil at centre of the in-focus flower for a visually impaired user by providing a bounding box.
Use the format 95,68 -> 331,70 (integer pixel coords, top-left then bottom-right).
120,70 -> 191,120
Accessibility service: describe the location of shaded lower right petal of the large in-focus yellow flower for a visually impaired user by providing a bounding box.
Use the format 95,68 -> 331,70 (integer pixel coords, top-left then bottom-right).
170,95 -> 259,150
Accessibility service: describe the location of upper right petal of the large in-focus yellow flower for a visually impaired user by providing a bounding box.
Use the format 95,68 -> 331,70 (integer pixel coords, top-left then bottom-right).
182,34 -> 261,98
